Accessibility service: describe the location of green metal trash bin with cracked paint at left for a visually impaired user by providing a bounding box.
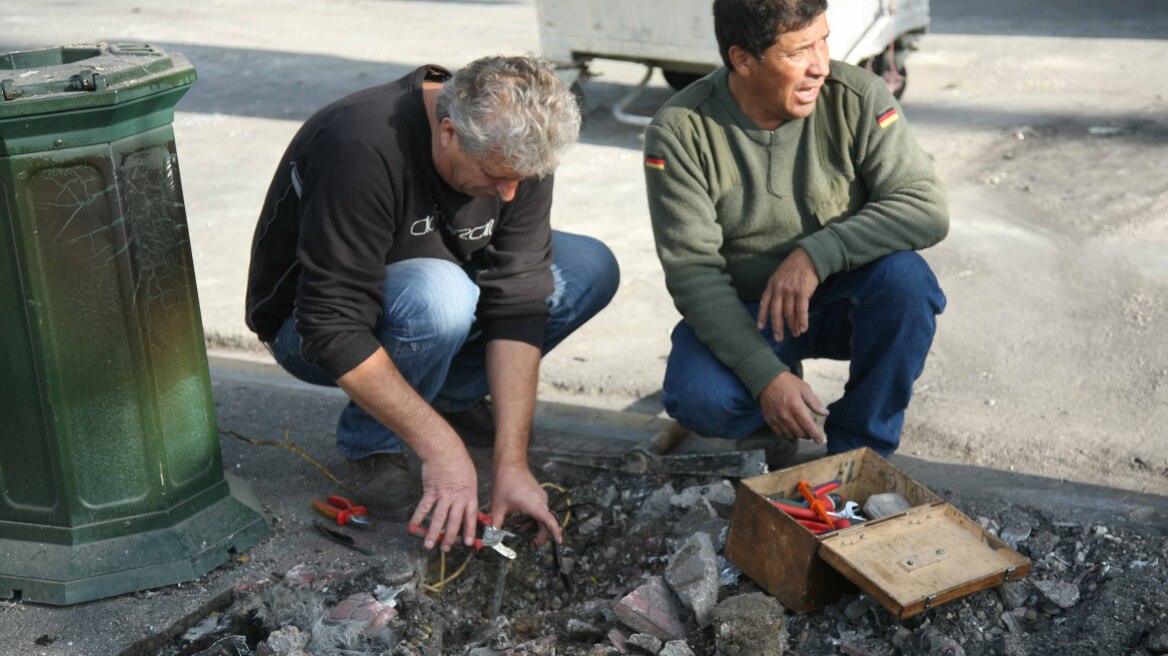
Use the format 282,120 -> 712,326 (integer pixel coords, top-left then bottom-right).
0,44 -> 269,605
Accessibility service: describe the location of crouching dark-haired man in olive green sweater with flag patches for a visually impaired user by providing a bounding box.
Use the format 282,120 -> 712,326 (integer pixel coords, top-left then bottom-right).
645,0 -> 948,459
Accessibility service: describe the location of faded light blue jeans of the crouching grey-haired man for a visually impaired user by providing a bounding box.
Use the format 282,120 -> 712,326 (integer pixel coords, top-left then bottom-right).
271,231 -> 620,460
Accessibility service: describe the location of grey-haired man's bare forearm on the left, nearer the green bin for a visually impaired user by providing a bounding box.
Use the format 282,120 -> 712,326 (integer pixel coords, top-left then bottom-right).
336,349 -> 463,461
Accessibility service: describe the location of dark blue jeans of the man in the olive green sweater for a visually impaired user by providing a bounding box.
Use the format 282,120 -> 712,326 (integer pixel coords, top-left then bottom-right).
663,251 -> 945,456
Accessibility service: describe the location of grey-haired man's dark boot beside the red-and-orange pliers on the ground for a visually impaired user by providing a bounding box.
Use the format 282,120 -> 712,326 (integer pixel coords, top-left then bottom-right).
349,453 -> 422,522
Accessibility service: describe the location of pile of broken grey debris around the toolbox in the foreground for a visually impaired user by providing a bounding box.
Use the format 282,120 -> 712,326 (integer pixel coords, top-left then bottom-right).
167,468 -> 1168,656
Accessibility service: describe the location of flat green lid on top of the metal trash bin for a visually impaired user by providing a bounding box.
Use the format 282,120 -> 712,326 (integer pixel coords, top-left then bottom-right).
0,43 -> 195,119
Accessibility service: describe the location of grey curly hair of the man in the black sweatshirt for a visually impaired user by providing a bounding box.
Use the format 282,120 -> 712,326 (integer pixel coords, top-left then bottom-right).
437,56 -> 580,177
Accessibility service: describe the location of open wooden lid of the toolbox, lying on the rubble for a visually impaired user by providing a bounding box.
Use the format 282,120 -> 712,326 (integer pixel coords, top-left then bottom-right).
819,503 -> 1030,619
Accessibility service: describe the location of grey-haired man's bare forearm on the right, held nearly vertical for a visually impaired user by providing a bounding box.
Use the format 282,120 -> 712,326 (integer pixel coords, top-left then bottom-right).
487,340 -> 541,469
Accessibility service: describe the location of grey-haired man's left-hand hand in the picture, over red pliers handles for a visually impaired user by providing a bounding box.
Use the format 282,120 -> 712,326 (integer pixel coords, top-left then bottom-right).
410,448 -> 479,552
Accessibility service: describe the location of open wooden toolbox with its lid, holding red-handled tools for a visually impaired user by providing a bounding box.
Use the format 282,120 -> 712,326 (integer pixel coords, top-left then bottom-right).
725,448 -> 1030,619
